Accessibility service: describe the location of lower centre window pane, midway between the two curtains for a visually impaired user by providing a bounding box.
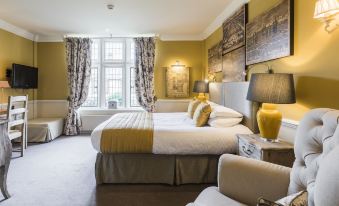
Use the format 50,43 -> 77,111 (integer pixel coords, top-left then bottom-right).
105,67 -> 123,107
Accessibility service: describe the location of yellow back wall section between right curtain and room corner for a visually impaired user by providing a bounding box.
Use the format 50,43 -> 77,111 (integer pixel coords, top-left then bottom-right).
154,40 -> 204,99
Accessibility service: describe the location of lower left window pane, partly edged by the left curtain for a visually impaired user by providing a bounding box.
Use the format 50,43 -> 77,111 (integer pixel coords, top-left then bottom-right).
82,67 -> 99,107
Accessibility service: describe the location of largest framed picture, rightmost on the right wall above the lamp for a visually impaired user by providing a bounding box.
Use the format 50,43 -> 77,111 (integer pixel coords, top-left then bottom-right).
246,0 -> 294,65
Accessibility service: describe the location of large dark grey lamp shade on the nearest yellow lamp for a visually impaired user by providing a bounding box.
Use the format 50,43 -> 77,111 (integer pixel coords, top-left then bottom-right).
247,73 -> 296,104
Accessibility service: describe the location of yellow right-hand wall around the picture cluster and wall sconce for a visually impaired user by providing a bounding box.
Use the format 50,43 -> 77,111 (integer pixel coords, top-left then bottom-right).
204,0 -> 339,120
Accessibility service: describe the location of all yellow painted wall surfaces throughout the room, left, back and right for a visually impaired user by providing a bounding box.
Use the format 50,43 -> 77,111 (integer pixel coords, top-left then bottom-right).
0,0 -> 339,120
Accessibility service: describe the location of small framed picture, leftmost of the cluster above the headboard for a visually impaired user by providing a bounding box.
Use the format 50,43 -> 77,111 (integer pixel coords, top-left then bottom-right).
208,42 -> 222,74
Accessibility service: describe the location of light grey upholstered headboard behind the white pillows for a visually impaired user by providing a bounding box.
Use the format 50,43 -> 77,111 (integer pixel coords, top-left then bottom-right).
209,82 -> 259,133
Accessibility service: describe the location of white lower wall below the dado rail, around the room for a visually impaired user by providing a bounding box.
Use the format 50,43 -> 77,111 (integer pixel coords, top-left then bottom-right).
1,99 -> 299,143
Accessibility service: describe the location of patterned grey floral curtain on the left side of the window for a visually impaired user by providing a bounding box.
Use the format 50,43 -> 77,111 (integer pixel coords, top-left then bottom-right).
64,38 -> 91,135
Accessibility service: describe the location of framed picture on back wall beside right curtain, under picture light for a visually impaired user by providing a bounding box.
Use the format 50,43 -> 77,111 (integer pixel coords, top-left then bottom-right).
166,66 -> 190,98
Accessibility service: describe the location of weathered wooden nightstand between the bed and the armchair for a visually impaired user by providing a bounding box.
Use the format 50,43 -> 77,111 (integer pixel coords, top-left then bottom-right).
237,134 -> 295,167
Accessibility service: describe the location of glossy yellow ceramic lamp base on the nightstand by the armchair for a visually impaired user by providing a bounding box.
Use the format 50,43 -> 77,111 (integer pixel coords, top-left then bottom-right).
257,103 -> 282,142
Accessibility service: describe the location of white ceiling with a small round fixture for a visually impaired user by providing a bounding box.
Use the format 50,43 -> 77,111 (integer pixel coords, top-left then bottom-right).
0,0 -> 246,40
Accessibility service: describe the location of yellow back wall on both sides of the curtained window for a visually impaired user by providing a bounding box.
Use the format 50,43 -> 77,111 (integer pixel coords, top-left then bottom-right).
38,40 -> 203,100
